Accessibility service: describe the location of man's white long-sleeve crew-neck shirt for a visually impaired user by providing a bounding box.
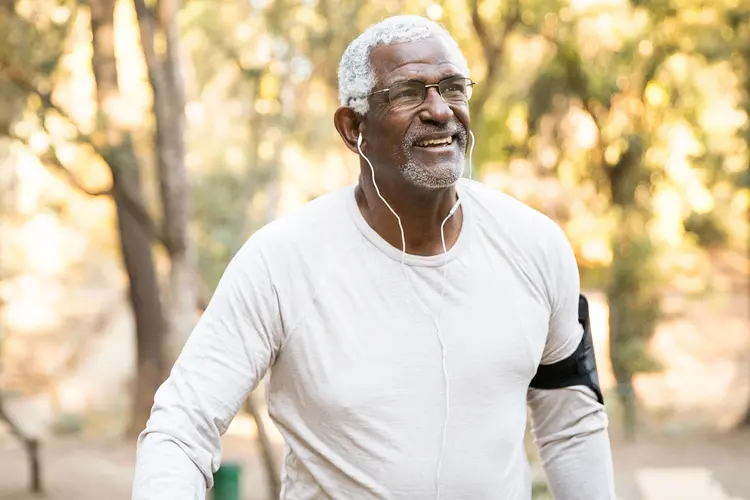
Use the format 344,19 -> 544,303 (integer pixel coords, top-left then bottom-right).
133,181 -> 614,500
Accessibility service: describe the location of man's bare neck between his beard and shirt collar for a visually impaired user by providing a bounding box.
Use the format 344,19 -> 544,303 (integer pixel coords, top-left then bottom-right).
355,170 -> 463,256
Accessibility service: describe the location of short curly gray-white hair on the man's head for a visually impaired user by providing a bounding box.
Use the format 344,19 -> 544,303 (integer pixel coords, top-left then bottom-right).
338,16 -> 469,115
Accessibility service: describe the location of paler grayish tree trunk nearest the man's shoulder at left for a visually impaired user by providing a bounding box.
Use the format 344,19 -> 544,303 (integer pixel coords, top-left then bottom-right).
134,0 -> 197,359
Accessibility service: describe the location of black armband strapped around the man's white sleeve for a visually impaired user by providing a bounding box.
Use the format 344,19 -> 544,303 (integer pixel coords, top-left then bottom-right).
530,295 -> 604,404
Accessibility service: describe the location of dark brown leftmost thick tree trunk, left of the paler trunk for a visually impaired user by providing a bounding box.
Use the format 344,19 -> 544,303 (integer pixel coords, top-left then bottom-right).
89,0 -> 166,437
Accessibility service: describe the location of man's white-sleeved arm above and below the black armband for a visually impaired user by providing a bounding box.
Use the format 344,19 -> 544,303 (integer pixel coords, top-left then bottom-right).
528,228 -> 615,500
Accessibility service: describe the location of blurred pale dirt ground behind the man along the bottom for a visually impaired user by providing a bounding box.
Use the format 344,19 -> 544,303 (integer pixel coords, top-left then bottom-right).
0,431 -> 750,500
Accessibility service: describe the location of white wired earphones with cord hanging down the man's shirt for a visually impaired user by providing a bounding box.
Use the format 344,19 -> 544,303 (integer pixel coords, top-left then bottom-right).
357,131 -> 475,500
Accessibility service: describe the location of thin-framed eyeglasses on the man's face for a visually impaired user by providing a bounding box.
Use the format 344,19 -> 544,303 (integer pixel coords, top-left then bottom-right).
367,76 -> 475,108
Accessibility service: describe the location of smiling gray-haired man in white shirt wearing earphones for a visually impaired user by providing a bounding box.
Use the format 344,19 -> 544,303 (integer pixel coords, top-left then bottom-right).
133,16 -> 614,500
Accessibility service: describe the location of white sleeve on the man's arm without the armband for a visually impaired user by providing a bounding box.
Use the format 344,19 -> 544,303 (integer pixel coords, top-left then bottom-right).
132,233 -> 282,500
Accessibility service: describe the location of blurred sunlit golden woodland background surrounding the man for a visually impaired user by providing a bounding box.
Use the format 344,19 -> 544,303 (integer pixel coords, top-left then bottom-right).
0,0 -> 750,500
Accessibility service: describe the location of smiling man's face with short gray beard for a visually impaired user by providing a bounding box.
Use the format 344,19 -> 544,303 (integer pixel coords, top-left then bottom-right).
365,37 -> 469,189
